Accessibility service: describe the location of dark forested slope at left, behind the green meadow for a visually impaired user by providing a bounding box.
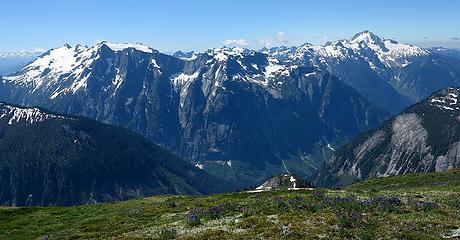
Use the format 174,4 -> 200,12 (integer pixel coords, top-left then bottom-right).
0,103 -> 232,206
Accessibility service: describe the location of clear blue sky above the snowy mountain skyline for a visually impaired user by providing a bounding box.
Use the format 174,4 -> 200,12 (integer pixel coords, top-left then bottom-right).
0,0 -> 460,52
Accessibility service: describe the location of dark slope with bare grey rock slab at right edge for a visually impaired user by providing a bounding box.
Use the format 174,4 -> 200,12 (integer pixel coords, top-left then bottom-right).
317,88 -> 460,186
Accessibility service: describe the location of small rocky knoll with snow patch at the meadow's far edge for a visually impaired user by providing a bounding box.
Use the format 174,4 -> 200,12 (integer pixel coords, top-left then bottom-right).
256,173 -> 311,191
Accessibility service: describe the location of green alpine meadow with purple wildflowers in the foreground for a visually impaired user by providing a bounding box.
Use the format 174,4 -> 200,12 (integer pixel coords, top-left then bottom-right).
0,170 -> 460,240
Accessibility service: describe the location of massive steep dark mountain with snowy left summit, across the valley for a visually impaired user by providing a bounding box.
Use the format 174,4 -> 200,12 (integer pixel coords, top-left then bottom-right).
0,43 -> 389,186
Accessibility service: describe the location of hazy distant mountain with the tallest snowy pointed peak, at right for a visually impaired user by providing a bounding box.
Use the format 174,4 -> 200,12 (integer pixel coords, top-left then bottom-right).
262,31 -> 460,114
